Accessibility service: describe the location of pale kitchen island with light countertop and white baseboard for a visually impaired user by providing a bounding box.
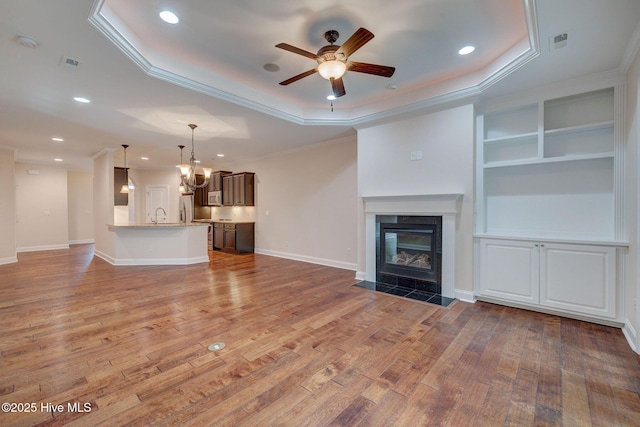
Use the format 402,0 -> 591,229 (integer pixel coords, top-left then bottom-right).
104,222 -> 209,265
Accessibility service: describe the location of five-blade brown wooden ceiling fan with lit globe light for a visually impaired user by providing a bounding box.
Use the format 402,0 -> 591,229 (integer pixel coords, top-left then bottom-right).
276,28 -> 396,98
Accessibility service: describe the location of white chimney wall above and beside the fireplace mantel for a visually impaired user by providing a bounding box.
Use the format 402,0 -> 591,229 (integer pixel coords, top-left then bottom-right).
358,105 -> 474,292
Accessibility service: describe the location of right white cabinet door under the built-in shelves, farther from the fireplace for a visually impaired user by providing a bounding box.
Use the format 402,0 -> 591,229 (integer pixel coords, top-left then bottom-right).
540,243 -> 616,318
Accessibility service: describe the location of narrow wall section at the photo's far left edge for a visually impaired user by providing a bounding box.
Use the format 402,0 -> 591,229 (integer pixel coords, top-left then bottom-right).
0,148 -> 18,265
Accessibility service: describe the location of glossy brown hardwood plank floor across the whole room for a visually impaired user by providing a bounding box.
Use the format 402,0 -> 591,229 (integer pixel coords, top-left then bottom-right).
0,245 -> 640,426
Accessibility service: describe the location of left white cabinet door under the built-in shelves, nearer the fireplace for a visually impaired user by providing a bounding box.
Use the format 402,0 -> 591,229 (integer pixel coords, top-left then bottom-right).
479,239 -> 540,304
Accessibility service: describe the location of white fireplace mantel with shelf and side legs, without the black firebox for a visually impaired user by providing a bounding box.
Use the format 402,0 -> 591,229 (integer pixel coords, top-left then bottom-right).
361,194 -> 463,298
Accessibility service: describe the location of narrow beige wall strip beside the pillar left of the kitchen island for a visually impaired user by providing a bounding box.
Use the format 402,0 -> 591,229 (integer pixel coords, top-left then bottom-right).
67,171 -> 94,244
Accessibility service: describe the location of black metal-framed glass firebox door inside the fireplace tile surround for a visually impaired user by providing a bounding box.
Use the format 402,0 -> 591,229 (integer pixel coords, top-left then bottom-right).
380,223 -> 437,281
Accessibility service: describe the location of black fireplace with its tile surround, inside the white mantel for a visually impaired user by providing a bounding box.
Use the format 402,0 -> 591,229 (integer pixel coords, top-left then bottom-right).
376,215 -> 442,293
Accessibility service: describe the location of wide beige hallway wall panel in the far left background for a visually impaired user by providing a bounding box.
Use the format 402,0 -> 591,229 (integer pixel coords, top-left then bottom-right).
15,163 -> 69,252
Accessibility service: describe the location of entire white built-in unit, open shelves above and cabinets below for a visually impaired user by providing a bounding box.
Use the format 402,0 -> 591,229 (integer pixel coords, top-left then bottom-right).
475,85 -> 627,321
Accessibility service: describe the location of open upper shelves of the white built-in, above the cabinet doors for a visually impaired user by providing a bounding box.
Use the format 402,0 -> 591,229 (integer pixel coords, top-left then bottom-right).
476,87 -> 623,242
